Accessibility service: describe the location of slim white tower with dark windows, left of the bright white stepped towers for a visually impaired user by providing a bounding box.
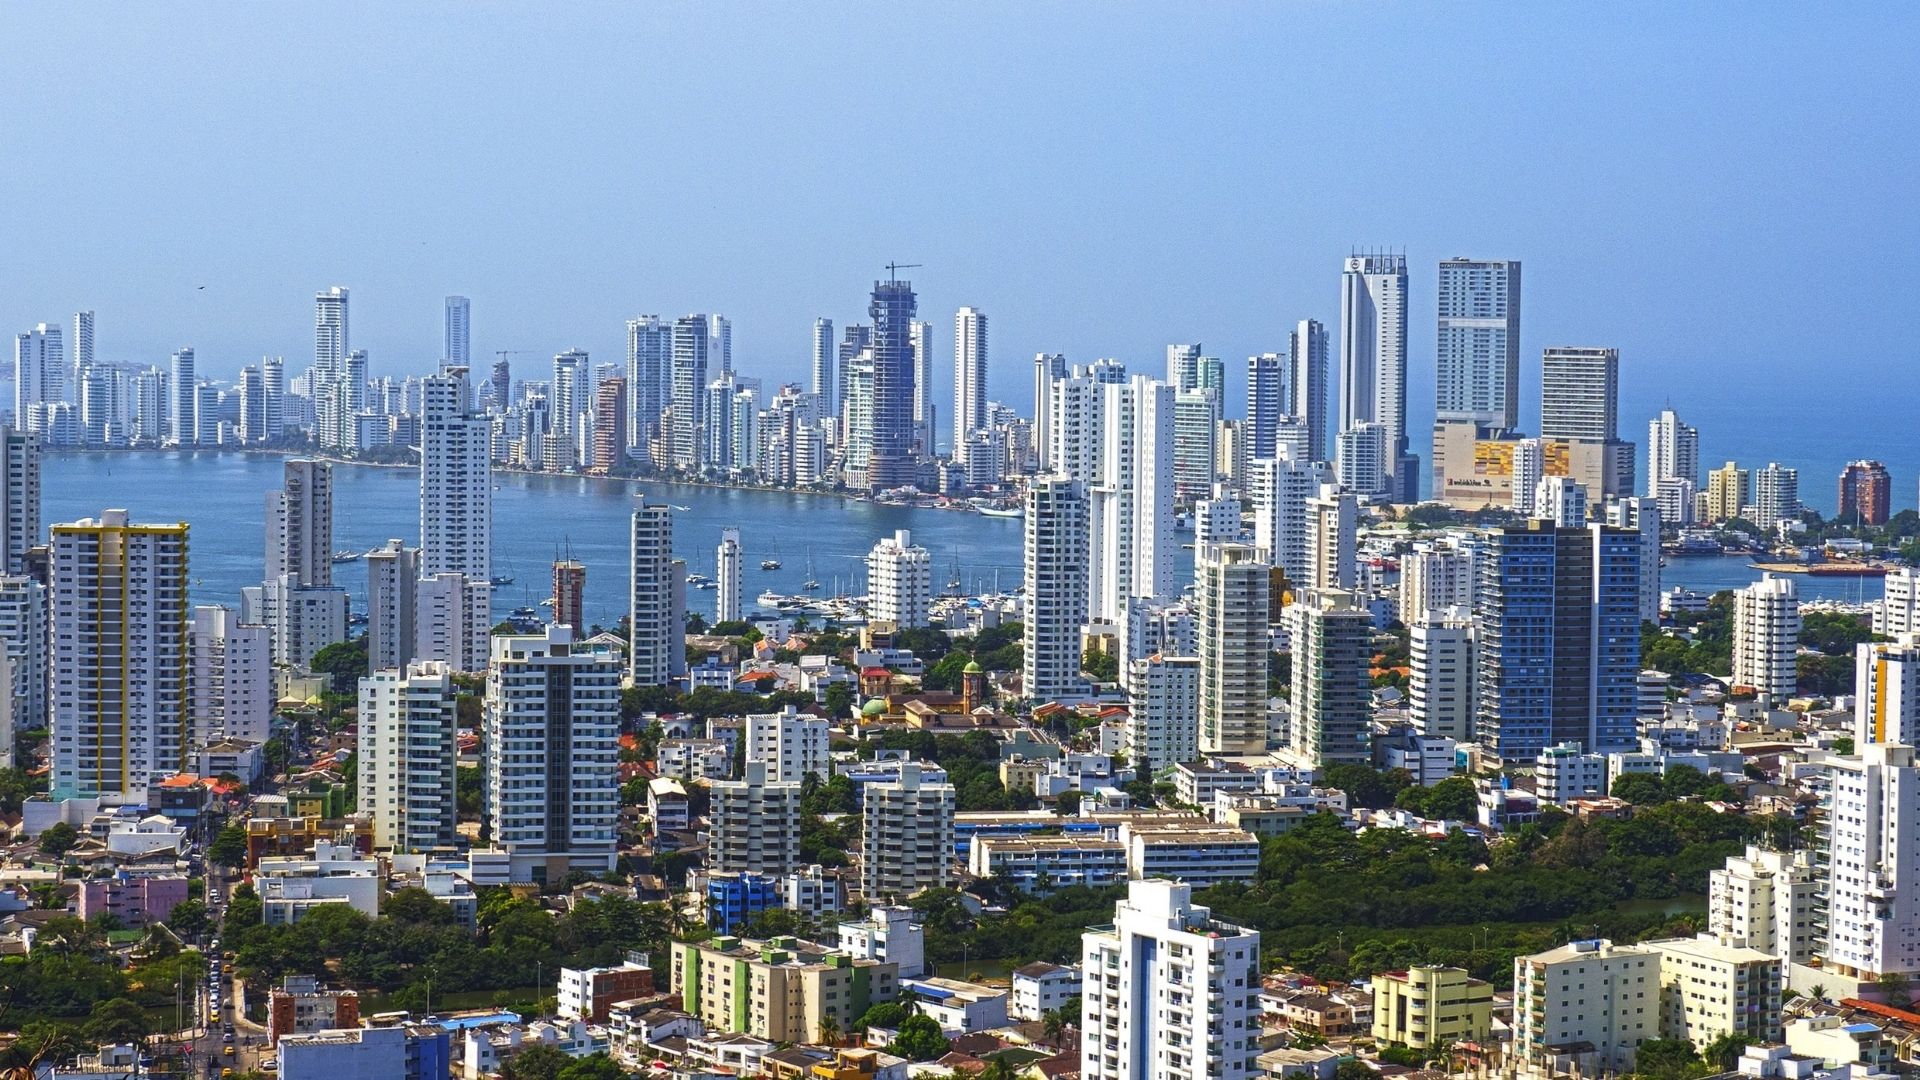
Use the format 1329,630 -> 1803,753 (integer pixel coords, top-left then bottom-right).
1021,477 -> 1087,701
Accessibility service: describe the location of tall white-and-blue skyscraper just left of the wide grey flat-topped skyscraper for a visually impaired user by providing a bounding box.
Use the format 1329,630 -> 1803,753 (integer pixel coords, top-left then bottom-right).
1340,254 -> 1419,502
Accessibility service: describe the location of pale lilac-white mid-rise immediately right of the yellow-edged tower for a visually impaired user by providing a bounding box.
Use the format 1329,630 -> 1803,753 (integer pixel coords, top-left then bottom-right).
186,605 -> 275,746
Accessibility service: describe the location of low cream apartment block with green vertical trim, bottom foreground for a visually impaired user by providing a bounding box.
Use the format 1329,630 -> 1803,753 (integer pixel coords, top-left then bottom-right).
672,938 -> 900,1043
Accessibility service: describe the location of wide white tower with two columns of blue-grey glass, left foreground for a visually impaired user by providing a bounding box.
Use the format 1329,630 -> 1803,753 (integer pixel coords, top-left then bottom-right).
482,626 -> 620,882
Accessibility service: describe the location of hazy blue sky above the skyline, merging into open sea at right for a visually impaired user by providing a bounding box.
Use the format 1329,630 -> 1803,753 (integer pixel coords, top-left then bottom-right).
0,2 -> 1920,505
